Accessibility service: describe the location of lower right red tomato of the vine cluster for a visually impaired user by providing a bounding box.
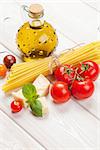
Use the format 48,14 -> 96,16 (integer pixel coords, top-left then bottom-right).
71,79 -> 94,100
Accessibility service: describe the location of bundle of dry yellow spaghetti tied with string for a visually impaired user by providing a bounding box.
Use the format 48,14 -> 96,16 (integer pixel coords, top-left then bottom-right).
3,42 -> 100,92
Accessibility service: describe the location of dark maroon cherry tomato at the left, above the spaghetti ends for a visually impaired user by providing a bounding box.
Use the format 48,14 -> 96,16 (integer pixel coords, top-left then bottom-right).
3,55 -> 16,69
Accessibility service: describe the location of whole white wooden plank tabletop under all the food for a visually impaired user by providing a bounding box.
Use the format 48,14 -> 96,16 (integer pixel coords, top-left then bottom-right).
0,0 -> 100,150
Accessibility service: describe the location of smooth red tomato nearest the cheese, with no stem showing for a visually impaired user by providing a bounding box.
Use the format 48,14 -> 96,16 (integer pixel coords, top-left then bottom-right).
51,81 -> 71,103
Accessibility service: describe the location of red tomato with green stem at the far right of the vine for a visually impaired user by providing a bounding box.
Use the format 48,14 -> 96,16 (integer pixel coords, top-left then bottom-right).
77,60 -> 99,81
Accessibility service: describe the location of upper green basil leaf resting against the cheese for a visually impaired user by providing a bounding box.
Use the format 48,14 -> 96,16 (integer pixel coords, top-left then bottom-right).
22,83 -> 37,100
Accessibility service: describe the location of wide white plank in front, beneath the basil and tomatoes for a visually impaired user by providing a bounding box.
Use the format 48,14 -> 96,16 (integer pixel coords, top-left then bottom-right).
0,46 -> 100,150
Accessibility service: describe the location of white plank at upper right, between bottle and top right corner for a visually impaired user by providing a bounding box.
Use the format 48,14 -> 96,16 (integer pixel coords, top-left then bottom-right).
43,1 -> 100,43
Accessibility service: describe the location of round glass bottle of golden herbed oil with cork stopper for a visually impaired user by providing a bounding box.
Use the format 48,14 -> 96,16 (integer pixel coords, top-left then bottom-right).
16,4 -> 58,61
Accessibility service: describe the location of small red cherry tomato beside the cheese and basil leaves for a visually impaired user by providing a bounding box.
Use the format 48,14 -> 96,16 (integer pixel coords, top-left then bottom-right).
11,101 -> 23,113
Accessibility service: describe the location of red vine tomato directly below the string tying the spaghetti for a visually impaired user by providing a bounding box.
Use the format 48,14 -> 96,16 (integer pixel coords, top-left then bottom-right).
54,64 -> 75,86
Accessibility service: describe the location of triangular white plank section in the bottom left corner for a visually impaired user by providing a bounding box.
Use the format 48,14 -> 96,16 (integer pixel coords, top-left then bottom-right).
0,110 -> 44,150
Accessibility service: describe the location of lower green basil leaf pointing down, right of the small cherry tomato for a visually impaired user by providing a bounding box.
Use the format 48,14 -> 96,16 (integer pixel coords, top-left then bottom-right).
30,100 -> 42,117
